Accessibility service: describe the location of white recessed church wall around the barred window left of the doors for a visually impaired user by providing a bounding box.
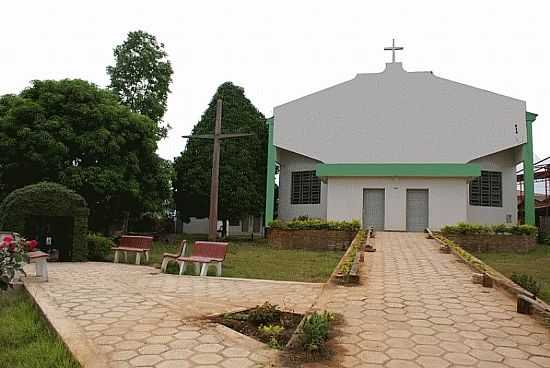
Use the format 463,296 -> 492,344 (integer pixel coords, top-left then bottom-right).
277,149 -> 327,220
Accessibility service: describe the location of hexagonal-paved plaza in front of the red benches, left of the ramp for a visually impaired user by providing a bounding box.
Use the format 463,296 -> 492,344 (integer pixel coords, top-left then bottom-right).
25,262 -> 322,368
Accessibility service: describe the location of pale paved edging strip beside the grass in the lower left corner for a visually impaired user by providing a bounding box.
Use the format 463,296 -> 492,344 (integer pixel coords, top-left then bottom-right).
23,278 -> 108,368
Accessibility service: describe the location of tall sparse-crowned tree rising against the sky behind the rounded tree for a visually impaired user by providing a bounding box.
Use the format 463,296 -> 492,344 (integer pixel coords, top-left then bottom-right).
107,31 -> 173,135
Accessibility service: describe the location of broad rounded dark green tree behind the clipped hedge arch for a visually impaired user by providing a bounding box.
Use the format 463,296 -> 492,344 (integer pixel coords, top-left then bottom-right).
0,79 -> 171,231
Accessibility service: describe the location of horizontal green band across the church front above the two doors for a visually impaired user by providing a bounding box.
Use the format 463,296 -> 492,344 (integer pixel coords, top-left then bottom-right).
317,163 -> 481,177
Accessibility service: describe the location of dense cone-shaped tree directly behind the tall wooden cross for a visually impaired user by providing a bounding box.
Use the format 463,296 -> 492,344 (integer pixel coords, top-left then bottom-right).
174,82 -> 267,224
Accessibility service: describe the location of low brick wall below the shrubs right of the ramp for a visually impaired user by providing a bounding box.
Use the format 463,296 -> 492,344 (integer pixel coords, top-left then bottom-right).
442,233 -> 537,253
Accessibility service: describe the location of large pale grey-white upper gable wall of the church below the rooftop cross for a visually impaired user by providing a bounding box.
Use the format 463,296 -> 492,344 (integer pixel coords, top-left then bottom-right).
274,63 -> 526,163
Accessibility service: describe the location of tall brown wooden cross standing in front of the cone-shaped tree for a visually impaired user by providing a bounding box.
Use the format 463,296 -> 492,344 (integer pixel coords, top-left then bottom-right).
183,98 -> 252,241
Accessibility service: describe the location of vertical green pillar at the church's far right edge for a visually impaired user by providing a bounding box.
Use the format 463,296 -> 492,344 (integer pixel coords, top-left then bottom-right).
523,111 -> 538,225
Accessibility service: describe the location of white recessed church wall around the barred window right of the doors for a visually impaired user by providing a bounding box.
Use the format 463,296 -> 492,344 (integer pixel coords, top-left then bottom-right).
468,147 -> 521,225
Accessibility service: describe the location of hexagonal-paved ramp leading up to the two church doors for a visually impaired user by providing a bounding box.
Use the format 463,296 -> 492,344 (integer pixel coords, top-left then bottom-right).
316,232 -> 550,368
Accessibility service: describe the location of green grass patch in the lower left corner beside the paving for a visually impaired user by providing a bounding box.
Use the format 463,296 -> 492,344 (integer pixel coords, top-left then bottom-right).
0,290 -> 80,368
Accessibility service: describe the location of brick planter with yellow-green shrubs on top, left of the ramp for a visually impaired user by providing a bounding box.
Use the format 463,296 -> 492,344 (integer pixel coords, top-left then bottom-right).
267,220 -> 361,250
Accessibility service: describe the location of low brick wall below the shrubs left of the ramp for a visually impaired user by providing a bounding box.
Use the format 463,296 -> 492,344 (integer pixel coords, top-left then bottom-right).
267,229 -> 357,249
